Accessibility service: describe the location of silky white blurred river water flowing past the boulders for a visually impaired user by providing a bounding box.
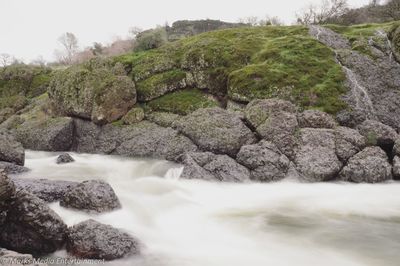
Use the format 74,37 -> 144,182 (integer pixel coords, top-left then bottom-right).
18,151 -> 400,266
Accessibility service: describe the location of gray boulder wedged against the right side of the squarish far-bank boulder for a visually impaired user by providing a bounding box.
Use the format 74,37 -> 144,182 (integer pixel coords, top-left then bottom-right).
335,127 -> 366,162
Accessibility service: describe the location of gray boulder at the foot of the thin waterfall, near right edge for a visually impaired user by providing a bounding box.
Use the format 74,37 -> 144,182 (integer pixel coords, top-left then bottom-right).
357,120 -> 398,147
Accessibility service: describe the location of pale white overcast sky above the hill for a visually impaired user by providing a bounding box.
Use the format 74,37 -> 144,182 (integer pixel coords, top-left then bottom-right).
0,0 -> 368,61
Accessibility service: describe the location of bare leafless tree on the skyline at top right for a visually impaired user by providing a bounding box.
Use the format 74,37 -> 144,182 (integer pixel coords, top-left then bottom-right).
296,0 -> 348,25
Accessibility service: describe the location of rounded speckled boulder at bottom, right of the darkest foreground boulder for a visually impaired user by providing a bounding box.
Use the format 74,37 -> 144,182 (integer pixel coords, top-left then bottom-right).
67,220 -> 140,260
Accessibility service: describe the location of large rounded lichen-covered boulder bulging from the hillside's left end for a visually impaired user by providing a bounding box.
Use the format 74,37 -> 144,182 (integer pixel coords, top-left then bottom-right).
48,58 -> 136,124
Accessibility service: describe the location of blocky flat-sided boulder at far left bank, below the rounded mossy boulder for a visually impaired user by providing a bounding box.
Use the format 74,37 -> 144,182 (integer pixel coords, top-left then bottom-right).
14,117 -> 74,151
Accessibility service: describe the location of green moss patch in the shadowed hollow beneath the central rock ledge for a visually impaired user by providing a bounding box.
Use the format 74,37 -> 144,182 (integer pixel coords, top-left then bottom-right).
147,89 -> 219,115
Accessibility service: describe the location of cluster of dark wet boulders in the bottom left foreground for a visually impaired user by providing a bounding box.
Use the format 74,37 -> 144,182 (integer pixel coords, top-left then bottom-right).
0,167 -> 140,266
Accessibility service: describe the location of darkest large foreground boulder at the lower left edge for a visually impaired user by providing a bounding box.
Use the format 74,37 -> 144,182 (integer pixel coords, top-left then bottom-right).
0,190 -> 67,255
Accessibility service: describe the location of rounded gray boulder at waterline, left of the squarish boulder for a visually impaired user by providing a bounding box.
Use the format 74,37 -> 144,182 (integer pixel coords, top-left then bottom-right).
236,141 -> 290,181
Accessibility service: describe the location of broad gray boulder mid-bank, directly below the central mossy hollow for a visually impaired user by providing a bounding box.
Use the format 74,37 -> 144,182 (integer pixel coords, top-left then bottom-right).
174,108 -> 256,157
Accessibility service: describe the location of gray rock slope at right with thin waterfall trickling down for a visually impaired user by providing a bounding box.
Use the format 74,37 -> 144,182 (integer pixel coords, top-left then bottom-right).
310,26 -> 400,130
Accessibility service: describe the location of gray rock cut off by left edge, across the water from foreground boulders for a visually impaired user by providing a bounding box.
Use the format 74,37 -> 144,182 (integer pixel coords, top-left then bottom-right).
0,133 -> 25,166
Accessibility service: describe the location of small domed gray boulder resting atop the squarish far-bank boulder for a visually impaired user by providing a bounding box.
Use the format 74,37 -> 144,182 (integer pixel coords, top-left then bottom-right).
298,110 -> 337,128
